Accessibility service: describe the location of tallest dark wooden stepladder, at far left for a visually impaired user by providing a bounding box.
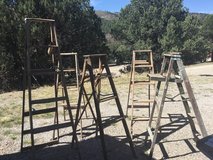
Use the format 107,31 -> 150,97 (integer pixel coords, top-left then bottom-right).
21,18 -> 77,151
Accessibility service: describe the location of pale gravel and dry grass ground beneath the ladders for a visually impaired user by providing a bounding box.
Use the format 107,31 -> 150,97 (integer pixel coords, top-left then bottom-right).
0,62 -> 213,160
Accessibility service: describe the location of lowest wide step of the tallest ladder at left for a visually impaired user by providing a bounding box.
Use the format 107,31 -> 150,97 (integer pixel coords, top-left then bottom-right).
23,122 -> 72,135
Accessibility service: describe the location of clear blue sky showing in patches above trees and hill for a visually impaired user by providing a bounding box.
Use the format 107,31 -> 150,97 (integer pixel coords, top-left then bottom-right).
90,0 -> 213,14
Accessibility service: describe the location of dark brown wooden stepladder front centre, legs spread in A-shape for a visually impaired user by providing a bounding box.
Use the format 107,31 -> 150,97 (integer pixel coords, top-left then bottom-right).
72,54 -> 135,160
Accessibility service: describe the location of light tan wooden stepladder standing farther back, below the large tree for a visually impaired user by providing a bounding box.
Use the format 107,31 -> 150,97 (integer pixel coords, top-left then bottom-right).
126,50 -> 155,136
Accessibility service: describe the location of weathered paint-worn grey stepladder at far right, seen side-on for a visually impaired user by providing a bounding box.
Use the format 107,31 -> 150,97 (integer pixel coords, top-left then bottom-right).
147,52 -> 207,157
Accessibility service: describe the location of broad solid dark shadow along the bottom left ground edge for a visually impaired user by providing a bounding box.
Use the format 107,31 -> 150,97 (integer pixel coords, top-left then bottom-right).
0,135 -> 148,160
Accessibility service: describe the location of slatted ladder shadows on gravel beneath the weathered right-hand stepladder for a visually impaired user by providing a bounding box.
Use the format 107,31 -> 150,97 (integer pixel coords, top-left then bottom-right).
135,114 -> 199,159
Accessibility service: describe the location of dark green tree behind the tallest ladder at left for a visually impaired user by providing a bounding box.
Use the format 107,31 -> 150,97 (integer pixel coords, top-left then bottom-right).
0,0 -> 107,90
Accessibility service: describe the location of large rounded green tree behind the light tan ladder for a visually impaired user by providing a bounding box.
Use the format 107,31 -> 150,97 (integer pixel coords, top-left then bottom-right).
112,0 -> 188,67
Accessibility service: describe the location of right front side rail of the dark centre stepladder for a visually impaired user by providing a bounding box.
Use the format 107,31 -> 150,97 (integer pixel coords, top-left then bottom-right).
104,57 -> 136,157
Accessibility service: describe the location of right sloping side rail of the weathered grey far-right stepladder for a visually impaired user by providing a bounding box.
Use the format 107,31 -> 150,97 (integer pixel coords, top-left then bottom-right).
177,60 -> 208,137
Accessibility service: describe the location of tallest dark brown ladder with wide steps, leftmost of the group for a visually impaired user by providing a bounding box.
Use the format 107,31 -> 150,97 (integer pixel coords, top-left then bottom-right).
21,18 -> 77,151
